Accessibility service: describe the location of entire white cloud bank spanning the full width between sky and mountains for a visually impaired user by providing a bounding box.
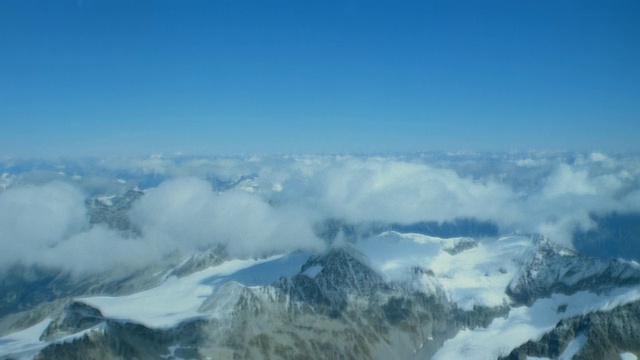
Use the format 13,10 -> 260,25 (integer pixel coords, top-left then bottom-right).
0,153 -> 640,273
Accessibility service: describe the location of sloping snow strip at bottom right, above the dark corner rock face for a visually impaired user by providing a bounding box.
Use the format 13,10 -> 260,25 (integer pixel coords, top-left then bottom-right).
433,287 -> 640,359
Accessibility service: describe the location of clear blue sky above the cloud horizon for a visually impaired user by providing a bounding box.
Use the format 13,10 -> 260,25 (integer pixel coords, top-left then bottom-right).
0,0 -> 640,155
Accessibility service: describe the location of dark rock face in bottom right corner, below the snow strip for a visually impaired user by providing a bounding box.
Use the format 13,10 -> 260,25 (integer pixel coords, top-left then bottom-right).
505,301 -> 640,360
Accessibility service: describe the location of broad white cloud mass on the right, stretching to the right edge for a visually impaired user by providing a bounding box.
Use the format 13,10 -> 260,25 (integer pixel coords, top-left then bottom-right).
277,157 -> 640,246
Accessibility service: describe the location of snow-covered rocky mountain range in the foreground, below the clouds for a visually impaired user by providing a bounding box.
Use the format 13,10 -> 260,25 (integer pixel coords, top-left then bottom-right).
0,226 -> 640,359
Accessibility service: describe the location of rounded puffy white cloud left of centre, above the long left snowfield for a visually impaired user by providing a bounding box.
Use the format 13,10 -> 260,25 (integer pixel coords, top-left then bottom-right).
131,178 -> 322,256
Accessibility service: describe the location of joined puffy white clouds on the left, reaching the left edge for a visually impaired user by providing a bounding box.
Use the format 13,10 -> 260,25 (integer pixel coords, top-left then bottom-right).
0,177 -> 324,274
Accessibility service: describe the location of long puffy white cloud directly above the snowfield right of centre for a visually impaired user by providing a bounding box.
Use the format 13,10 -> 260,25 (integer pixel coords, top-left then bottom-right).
298,158 -> 513,224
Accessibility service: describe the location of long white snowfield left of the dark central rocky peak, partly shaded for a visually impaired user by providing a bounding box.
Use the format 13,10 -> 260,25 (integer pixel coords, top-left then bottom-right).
76,253 -> 309,328
